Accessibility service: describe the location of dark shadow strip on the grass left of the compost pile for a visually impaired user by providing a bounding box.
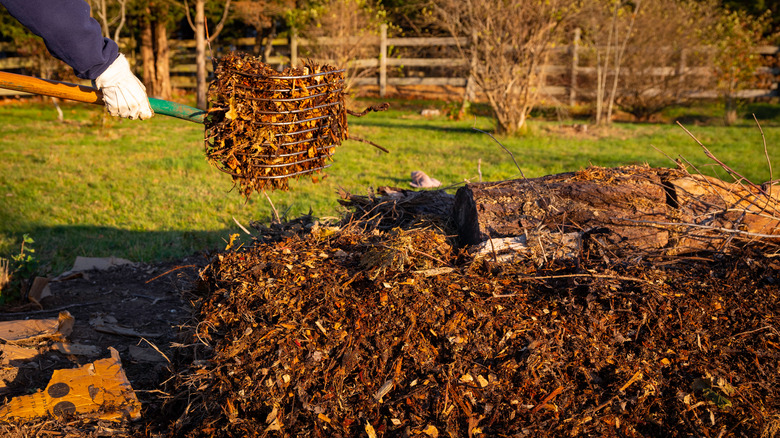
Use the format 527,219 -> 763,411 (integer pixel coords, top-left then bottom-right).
5,225 -> 241,275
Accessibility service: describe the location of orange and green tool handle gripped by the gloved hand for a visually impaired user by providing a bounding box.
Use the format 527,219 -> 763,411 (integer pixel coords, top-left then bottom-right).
0,71 -> 206,123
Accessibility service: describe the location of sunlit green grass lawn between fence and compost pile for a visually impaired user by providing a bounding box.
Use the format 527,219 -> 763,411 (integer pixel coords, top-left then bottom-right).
0,101 -> 780,273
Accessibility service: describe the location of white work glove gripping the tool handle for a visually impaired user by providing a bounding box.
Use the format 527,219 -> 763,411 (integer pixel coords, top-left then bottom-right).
95,53 -> 154,120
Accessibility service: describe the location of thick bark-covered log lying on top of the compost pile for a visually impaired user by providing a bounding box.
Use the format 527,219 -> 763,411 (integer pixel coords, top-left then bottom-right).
453,166 -> 780,254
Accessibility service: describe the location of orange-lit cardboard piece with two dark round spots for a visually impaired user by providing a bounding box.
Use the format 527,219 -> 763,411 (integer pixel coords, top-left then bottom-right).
0,348 -> 141,421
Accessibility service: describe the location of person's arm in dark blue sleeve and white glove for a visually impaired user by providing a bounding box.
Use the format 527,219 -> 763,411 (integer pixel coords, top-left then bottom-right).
0,0 -> 154,119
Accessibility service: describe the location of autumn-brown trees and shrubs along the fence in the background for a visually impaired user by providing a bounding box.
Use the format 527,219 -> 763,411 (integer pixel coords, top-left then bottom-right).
0,0 -> 780,134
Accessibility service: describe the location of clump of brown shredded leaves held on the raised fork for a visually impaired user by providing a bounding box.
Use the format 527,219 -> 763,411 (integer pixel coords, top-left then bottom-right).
205,53 -> 348,197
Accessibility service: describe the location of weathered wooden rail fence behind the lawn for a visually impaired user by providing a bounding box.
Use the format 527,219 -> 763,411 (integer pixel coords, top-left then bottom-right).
0,26 -> 780,101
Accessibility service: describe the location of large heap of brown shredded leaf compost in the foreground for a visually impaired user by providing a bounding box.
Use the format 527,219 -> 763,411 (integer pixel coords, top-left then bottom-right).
168,192 -> 780,437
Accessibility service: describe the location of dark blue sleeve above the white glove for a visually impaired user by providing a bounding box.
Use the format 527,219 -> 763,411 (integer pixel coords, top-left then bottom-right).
0,0 -> 119,79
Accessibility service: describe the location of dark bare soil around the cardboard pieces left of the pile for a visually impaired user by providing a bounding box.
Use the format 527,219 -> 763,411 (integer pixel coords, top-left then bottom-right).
0,255 -> 208,436
